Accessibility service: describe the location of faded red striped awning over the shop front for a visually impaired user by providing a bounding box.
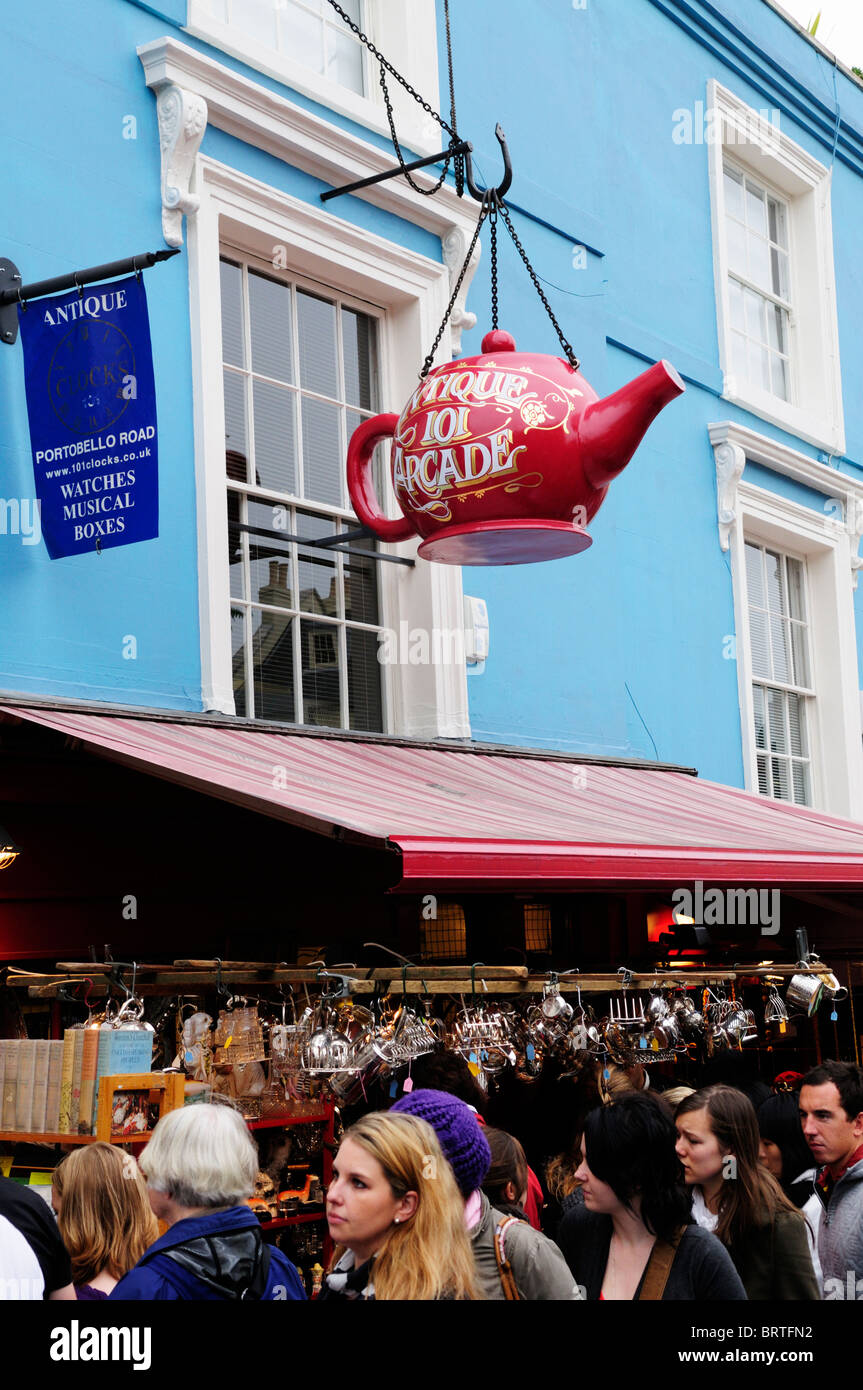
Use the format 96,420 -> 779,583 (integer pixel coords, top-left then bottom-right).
0,705 -> 863,890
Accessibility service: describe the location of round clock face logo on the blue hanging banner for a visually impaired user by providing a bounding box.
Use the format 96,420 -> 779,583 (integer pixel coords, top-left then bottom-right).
49,318 -> 135,435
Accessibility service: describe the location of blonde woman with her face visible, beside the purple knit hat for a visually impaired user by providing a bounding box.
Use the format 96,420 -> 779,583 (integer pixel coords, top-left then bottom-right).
320,1113 -> 478,1301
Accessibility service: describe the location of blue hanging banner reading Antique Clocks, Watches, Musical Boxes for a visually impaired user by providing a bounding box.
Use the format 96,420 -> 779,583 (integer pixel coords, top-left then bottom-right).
18,275 -> 158,560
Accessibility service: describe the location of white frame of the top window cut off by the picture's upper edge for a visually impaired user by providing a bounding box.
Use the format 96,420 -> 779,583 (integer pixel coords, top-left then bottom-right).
183,0 -> 446,154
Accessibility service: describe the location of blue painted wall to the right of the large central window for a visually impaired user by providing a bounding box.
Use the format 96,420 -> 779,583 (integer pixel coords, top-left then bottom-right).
442,0 -> 863,785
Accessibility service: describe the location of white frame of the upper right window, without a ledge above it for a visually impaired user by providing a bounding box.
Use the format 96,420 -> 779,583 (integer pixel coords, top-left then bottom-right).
707,81 -> 845,455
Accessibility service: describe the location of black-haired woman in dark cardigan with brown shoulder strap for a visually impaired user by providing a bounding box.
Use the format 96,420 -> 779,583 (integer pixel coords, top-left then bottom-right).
559,1094 -> 746,1301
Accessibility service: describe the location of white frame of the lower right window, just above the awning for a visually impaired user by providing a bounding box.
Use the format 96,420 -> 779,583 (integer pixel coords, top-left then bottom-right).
709,421 -> 863,820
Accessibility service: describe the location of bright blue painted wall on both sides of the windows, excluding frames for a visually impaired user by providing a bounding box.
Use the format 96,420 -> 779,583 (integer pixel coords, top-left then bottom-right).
0,0 -> 863,785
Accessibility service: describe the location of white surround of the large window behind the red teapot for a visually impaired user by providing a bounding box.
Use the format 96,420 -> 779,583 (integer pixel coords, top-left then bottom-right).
188,156 -> 470,738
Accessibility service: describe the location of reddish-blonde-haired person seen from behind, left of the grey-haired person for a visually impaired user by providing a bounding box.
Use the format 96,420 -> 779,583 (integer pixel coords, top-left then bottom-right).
53,1144 -> 158,1300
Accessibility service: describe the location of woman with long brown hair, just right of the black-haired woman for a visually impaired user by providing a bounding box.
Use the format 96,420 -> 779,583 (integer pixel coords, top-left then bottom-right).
674,1086 -> 820,1300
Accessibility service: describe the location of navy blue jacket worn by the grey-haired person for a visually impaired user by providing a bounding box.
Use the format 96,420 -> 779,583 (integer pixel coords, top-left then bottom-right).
110,1207 -> 306,1301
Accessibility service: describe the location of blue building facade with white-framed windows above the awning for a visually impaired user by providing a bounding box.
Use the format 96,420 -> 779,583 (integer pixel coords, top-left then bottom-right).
0,0 -> 863,819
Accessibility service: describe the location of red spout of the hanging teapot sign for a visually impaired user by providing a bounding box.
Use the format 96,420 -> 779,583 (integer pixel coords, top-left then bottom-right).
578,360 -> 687,488
